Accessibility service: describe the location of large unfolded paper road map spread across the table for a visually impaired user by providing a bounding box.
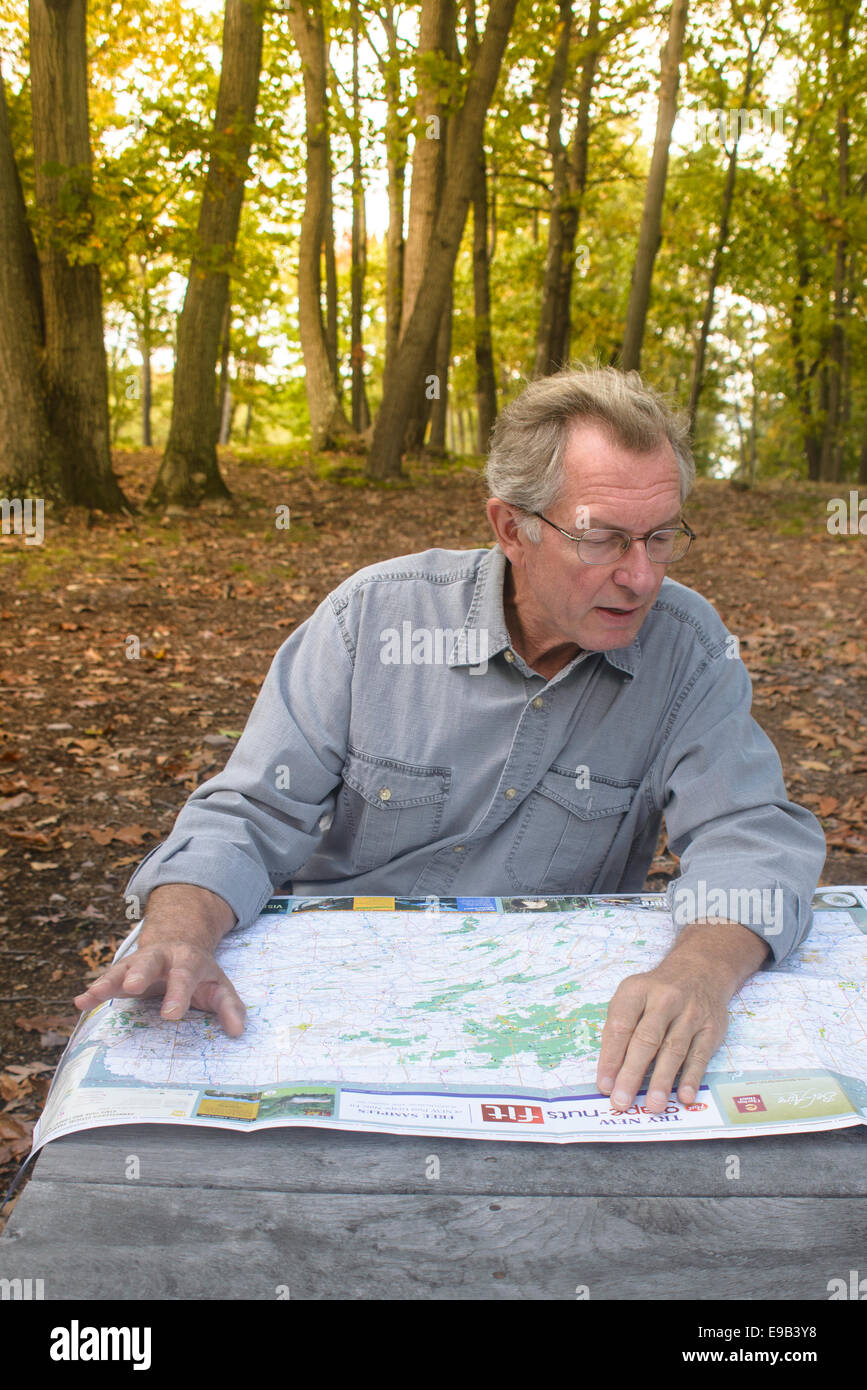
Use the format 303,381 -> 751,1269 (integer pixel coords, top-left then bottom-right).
33,887 -> 867,1150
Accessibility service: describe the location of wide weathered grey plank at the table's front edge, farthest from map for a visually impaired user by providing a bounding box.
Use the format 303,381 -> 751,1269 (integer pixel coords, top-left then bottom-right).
0,1182 -> 867,1301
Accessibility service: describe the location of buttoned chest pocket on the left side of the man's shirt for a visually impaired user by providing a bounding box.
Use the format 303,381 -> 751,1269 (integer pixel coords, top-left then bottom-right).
336,751 -> 452,873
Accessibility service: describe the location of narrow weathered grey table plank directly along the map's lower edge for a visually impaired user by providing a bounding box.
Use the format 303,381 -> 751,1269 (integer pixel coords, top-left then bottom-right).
25,1125 -> 867,1198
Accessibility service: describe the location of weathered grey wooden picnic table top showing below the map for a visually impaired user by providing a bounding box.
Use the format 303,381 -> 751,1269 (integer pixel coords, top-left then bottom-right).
0,1125 -> 867,1301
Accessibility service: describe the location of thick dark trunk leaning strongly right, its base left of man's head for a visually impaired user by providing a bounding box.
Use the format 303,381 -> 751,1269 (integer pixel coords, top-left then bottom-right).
368,0 -> 517,478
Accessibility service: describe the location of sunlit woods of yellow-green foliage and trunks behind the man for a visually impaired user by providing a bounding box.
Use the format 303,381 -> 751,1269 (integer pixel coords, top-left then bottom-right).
0,0 -> 867,510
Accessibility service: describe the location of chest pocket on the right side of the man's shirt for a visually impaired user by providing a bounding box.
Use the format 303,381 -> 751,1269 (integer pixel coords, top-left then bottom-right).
506,769 -> 636,892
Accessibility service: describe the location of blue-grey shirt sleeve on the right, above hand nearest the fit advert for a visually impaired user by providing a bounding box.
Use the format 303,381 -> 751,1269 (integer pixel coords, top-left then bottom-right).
654,634 -> 825,967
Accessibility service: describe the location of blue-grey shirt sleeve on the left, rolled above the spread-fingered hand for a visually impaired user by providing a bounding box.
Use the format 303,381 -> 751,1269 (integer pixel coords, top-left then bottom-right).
126,598 -> 353,924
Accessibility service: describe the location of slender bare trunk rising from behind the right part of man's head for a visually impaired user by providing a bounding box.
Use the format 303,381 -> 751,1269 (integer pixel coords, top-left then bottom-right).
620,0 -> 688,371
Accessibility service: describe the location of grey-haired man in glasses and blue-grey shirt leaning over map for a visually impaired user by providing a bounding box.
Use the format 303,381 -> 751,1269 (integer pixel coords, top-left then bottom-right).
75,368 -> 825,1112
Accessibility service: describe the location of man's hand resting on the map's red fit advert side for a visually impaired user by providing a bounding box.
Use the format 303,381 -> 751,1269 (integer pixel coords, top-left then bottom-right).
596,922 -> 768,1115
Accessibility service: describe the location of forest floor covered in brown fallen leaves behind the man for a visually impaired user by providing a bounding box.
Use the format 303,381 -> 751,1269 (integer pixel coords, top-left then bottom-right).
0,450 -> 867,1227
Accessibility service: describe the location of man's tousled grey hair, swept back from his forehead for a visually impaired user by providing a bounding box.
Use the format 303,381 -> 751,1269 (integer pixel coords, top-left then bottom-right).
485,366 -> 696,543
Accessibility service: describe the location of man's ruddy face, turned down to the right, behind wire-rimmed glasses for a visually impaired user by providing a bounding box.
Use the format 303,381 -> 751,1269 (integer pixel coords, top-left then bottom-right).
507,421 -> 681,652
